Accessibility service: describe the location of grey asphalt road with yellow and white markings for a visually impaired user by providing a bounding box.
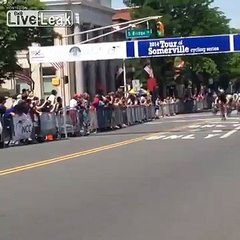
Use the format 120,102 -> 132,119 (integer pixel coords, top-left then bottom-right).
0,114 -> 240,240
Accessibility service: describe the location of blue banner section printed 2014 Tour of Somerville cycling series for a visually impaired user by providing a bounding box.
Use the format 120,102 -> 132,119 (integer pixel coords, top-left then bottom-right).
127,35 -> 230,58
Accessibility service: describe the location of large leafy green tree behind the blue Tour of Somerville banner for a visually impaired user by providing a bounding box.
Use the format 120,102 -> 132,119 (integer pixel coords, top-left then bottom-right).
127,0 -> 230,97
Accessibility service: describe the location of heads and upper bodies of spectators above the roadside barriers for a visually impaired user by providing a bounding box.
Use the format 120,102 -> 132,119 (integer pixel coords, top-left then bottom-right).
0,86 -> 210,120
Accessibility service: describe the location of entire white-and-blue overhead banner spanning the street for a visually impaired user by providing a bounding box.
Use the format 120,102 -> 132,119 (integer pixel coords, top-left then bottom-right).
29,34 -> 240,64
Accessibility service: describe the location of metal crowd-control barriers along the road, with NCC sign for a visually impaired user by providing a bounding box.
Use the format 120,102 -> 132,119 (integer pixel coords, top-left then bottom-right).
0,98 -> 209,147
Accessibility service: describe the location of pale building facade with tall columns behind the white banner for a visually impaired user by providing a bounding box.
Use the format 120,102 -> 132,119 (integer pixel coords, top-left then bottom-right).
4,0 -> 124,101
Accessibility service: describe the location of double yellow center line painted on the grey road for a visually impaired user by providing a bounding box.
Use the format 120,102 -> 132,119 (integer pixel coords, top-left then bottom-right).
0,124 -> 206,176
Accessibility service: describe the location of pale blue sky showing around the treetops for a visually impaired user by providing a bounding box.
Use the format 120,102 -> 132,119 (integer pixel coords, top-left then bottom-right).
112,0 -> 240,28
